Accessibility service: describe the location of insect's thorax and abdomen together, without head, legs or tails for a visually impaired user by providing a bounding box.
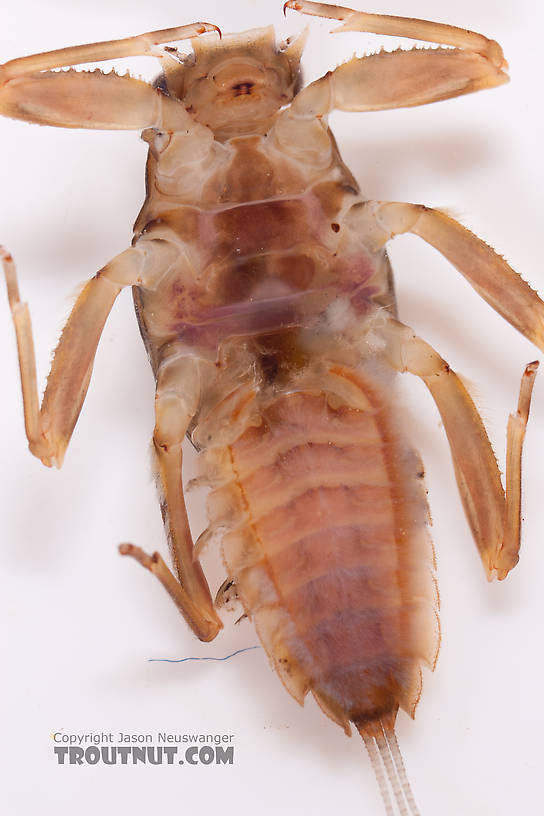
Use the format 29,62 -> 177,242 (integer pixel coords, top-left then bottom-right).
135,32 -> 438,731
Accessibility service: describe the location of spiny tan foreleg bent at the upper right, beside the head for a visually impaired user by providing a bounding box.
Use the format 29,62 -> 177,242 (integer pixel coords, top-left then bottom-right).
286,0 -> 508,118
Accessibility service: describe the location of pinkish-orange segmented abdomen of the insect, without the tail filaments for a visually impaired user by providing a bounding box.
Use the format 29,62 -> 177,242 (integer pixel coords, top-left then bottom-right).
202,369 -> 438,730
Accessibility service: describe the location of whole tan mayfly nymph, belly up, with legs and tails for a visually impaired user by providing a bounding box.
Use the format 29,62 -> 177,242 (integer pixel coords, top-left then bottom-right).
0,2 -> 544,813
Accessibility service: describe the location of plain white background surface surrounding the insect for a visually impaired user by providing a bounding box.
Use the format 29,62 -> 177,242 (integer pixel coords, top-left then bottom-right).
0,0 -> 544,816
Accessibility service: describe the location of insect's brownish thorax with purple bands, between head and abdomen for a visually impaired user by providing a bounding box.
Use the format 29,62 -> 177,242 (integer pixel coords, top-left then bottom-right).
131,123 -> 389,368
